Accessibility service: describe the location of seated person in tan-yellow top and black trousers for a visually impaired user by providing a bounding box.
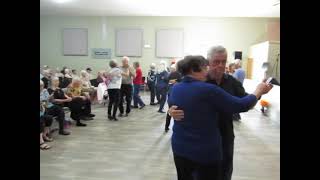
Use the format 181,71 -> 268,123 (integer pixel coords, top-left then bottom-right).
67,78 -> 95,126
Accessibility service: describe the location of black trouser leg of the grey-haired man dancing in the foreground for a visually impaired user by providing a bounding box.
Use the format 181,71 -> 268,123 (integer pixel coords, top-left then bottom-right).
222,137 -> 234,180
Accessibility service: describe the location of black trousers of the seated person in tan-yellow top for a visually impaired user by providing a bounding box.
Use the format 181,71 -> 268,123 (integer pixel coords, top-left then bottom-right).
65,97 -> 91,123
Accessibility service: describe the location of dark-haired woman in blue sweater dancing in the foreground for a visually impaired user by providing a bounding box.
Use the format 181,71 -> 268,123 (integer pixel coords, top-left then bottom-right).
169,56 -> 272,180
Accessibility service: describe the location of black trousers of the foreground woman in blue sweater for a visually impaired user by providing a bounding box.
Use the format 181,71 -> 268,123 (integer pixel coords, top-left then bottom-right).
173,154 -> 221,180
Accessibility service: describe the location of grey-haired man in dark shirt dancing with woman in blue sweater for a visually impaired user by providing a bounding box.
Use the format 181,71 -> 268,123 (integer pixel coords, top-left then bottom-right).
169,46 -> 254,180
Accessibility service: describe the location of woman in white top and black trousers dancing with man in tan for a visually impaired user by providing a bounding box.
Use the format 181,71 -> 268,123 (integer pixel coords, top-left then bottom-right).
108,60 -> 122,121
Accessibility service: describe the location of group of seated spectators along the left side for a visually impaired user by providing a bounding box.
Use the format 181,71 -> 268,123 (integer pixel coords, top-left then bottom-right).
40,69 -> 95,150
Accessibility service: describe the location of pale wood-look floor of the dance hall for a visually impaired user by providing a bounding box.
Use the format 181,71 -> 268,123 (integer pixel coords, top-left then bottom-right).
40,94 -> 280,180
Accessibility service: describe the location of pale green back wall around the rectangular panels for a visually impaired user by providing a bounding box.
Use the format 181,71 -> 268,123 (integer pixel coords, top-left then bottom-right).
40,16 -> 279,75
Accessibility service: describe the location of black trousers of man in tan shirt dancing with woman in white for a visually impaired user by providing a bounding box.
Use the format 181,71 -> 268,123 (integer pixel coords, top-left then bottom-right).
119,84 -> 132,114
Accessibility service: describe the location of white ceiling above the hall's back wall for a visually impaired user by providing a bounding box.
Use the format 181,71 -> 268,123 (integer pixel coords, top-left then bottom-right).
40,0 -> 280,17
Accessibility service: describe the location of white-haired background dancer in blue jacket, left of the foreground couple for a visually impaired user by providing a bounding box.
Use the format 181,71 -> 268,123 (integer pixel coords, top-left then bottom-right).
156,61 -> 169,113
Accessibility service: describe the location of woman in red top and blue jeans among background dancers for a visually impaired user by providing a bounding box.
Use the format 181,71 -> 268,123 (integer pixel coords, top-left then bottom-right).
133,62 -> 146,109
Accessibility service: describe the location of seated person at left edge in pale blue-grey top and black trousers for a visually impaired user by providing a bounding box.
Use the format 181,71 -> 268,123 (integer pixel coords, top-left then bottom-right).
40,80 -> 70,135
